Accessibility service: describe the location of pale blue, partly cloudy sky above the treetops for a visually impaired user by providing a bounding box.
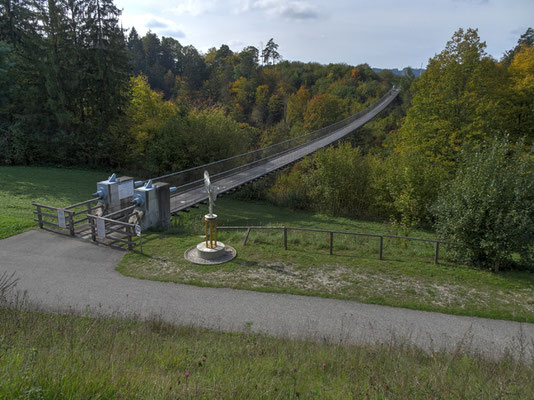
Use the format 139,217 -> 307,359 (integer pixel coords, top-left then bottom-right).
115,0 -> 534,69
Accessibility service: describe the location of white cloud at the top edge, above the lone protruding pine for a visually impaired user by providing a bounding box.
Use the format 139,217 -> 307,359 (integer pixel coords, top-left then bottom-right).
241,0 -> 321,20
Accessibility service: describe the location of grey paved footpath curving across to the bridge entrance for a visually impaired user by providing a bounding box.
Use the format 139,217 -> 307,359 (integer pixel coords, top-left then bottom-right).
0,230 -> 534,361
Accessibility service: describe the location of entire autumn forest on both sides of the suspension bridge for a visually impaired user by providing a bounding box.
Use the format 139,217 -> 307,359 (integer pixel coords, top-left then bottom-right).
0,0 -> 534,269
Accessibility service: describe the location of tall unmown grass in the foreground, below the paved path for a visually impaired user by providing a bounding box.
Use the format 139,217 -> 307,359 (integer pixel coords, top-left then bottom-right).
0,308 -> 534,400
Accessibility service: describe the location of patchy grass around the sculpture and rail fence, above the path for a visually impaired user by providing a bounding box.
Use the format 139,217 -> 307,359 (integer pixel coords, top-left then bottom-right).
118,198 -> 534,322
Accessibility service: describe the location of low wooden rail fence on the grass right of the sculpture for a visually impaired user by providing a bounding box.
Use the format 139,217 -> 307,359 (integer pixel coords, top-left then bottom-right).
217,226 -> 459,264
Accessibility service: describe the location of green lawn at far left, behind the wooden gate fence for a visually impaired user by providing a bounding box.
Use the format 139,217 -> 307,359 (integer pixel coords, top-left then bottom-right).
0,167 -> 107,239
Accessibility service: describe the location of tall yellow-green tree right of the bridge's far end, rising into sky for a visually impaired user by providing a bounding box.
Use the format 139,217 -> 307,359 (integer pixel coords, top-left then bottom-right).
396,29 -> 496,166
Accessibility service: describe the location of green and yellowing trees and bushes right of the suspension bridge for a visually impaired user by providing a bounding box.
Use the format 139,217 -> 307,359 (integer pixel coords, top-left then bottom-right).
265,28 -> 534,269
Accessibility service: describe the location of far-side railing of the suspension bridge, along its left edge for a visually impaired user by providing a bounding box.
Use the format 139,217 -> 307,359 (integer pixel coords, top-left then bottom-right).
152,88 -> 395,186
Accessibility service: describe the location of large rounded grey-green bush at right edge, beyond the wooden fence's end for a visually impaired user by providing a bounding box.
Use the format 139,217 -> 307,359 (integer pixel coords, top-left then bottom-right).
433,139 -> 534,271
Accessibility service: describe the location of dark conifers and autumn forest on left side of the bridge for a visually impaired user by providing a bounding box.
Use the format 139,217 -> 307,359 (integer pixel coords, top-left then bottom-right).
0,0 -> 398,176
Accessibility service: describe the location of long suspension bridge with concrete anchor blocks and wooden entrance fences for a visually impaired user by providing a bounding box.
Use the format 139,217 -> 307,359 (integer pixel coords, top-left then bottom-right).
33,88 -> 399,248
